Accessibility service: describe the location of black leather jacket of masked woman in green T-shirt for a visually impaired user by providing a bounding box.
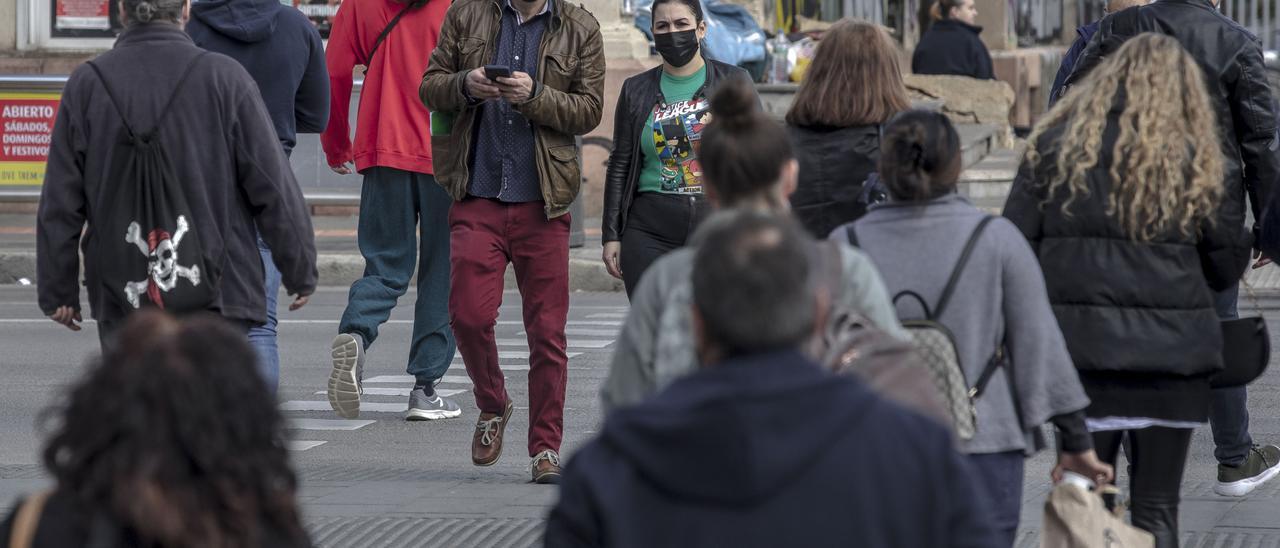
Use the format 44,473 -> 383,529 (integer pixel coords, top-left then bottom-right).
600,59 -> 751,242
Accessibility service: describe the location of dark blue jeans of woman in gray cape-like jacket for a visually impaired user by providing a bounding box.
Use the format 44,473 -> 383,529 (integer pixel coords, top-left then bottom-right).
966,451 -> 1027,548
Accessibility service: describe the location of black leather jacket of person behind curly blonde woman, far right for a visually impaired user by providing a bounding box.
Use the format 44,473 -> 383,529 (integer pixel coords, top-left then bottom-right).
1066,0 -> 1280,244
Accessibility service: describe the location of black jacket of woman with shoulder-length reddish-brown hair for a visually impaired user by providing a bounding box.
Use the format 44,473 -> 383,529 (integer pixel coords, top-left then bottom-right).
787,125 -> 879,238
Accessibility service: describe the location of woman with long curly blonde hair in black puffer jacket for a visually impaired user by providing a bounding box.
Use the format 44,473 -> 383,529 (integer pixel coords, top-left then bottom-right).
1005,33 -> 1251,547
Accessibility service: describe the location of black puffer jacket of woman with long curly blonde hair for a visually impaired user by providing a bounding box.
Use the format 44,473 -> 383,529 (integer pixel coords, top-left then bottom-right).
1005,108 -> 1251,421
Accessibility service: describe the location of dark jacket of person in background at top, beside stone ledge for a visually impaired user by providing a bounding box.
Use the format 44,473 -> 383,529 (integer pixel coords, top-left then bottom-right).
911,19 -> 996,79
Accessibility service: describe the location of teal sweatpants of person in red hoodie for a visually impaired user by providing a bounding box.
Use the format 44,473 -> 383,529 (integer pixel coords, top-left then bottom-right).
338,168 -> 457,383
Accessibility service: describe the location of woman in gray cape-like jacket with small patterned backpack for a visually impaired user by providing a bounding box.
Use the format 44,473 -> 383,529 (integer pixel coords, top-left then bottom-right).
832,110 -> 1111,545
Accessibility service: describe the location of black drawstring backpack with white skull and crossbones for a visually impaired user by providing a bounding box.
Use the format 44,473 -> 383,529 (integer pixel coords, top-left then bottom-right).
88,52 -> 218,314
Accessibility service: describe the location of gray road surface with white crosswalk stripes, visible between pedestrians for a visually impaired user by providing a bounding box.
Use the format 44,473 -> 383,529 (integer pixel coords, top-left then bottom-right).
0,286 -> 1280,547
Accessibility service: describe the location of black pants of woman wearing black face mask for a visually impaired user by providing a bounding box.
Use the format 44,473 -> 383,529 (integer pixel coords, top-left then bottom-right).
618,192 -> 710,297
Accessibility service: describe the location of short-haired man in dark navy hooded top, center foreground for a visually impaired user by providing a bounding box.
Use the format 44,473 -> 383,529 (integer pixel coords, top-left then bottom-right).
545,213 -> 997,548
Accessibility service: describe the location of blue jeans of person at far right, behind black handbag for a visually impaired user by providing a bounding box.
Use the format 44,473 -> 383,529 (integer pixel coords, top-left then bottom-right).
1208,286 -> 1253,466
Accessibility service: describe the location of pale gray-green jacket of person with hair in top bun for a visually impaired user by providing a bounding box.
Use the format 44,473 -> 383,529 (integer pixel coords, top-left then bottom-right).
600,211 -> 908,410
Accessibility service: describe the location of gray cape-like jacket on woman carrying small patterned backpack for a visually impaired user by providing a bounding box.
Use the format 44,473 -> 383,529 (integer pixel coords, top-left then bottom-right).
849,195 -> 1089,453
